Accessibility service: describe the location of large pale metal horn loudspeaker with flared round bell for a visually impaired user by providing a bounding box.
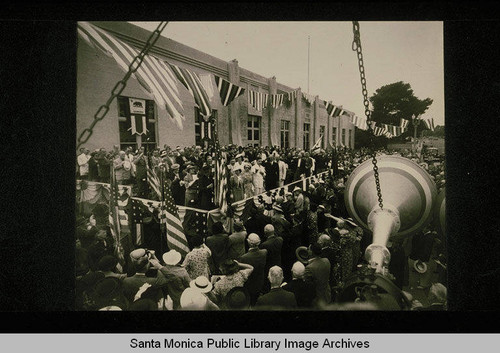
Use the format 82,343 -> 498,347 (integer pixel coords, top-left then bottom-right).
344,156 -> 437,273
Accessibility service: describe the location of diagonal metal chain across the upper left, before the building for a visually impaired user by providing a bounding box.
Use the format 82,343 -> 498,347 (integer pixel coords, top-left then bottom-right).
76,21 -> 168,151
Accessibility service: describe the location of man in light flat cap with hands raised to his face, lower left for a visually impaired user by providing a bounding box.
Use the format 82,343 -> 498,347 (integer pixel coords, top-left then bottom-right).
123,248 -> 167,302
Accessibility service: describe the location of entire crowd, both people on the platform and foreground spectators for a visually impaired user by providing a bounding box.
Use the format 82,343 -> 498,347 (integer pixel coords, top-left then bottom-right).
76,145 -> 446,311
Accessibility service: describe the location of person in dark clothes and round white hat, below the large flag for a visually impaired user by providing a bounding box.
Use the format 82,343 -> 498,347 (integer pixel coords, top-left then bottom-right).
151,250 -> 191,310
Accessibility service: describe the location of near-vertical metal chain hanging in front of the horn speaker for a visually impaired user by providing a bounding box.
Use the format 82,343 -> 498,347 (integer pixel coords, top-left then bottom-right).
352,21 -> 384,208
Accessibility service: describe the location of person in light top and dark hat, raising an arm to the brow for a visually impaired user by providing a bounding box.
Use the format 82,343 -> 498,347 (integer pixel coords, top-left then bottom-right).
212,259 -> 253,300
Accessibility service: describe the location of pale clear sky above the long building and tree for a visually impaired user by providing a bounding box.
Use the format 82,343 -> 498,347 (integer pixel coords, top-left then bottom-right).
132,21 -> 444,126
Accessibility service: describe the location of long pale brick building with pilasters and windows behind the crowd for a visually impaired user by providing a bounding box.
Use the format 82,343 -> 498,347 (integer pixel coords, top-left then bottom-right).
76,22 -> 354,150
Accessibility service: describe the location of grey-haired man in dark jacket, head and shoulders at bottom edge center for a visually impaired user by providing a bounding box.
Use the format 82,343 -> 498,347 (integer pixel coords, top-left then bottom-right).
255,266 -> 297,310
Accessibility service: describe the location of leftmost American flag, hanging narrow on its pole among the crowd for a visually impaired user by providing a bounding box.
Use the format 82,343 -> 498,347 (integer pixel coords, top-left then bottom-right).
109,165 -> 130,264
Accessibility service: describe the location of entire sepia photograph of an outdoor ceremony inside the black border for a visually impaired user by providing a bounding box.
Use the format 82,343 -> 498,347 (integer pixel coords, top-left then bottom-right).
75,21 -> 448,311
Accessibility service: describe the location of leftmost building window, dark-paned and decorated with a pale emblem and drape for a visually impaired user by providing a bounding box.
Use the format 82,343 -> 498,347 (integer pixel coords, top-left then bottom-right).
117,96 -> 156,150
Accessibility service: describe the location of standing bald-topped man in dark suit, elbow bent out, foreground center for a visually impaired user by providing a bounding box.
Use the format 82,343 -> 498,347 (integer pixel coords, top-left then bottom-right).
239,233 -> 267,305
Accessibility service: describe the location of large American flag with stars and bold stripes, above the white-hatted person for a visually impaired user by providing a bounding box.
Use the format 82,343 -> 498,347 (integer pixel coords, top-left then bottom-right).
160,171 -> 189,256
